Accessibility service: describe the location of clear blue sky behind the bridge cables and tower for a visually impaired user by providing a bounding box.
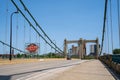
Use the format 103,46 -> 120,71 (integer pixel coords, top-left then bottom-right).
0,0 -> 118,53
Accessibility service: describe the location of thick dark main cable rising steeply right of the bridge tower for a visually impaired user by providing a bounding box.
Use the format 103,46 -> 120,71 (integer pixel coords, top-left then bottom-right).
100,0 -> 108,55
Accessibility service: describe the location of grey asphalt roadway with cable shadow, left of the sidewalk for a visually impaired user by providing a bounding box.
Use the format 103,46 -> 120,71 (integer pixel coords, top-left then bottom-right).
0,60 -> 84,80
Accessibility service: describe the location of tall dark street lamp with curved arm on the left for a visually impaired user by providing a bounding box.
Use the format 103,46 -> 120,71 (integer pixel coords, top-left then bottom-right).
9,11 -> 18,61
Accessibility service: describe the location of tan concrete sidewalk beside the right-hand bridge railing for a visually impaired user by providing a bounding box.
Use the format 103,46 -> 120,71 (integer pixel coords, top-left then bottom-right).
52,60 -> 115,80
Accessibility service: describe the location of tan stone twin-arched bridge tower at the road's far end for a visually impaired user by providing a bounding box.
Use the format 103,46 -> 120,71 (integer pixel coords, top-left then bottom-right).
64,38 -> 99,59
